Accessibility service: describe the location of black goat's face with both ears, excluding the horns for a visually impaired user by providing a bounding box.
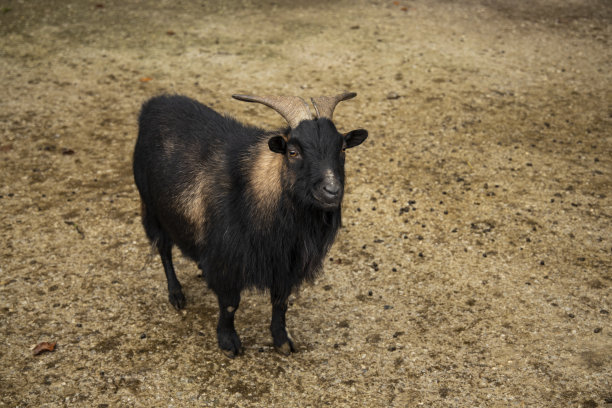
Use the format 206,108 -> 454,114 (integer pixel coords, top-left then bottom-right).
268,118 -> 368,211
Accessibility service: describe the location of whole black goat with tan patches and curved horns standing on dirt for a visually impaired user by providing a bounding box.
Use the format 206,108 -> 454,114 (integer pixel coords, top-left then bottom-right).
134,93 -> 368,357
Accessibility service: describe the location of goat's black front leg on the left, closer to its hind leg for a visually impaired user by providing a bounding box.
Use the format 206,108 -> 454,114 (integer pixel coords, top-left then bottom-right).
217,290 -> 242,358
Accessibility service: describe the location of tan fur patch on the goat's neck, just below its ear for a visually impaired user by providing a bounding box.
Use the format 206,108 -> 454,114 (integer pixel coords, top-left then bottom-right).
249,140 -> 283,224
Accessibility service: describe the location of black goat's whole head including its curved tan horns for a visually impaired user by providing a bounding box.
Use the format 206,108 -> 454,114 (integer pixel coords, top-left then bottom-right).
233,93 -> 368,210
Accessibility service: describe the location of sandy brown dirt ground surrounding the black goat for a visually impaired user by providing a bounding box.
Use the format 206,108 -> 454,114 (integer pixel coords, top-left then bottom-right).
0,0 -> 612,408
